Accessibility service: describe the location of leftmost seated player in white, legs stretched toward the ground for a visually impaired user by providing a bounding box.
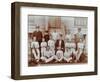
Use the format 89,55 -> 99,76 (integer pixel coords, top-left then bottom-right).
31,37 -> 40,62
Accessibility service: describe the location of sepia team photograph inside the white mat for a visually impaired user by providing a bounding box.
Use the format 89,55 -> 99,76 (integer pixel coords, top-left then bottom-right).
28,15 -> 88,66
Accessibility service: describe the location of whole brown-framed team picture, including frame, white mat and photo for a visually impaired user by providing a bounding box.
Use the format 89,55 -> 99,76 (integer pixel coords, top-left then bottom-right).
11,2 -> 98,80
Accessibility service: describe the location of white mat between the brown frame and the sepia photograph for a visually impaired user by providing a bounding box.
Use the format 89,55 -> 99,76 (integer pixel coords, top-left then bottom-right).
20,7 -> 94,75
